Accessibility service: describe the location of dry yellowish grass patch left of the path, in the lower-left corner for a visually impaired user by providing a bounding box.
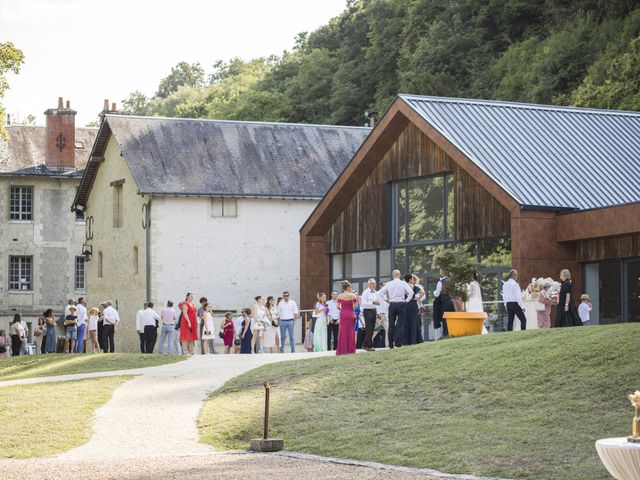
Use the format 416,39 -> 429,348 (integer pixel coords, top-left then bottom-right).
0,376 -> 131,459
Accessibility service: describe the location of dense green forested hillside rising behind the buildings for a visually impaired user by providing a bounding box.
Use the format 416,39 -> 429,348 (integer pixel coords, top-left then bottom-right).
124,0 -> 640,125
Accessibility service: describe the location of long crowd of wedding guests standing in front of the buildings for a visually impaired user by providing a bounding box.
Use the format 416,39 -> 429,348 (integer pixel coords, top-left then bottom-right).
0,269 -> 592,357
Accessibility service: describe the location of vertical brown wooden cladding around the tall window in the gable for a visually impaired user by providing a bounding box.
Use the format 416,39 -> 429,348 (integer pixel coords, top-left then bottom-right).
325,123 -> 511,253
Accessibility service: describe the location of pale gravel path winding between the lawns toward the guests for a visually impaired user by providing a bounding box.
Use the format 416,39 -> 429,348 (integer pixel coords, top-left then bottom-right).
0,352 -> 502,480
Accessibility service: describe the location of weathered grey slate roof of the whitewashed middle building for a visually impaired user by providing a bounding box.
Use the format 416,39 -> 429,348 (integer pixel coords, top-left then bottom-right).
75,115 -> 370,206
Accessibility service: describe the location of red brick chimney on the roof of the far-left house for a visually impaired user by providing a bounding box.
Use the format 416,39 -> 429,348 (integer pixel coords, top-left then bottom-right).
44,97 -> 77,169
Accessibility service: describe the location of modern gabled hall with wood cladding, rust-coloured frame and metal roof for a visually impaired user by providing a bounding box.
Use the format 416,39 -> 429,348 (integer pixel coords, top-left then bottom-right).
300,95 -> 640,324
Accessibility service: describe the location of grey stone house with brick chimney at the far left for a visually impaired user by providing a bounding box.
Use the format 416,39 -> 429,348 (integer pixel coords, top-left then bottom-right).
0,98 -> 97,338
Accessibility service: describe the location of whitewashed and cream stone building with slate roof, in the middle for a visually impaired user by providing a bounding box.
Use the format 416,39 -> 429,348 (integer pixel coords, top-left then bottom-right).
72,115 -> 369,351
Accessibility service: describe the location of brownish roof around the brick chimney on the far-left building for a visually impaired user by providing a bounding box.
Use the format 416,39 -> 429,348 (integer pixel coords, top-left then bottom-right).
0,125 -> 98,178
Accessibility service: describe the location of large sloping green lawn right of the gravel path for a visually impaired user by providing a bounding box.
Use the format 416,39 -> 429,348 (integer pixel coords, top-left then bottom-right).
199,324 -> 640,480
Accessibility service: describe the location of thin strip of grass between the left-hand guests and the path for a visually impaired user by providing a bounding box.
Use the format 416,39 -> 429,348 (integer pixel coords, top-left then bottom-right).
0,353 -> 186,381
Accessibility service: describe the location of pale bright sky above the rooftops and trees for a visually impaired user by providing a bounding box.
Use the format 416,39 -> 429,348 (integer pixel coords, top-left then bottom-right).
0,0 -> 346,126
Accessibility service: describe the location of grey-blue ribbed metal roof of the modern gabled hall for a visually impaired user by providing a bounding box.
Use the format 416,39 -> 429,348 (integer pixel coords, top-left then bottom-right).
400,95 -> 640,210
